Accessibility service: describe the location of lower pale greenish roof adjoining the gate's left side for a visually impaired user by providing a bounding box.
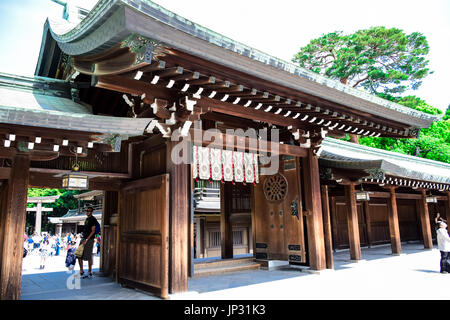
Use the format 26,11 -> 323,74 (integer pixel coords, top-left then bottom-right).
0,73 -> 153,136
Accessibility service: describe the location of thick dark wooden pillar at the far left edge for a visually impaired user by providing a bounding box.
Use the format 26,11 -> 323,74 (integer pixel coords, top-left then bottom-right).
0,154 -> 30,300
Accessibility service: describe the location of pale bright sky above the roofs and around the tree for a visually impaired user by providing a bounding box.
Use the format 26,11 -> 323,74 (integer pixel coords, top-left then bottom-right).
0,0 -> 450,111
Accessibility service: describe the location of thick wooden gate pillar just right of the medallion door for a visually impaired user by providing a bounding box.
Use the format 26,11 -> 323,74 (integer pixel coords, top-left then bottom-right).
300,149 -> 326,270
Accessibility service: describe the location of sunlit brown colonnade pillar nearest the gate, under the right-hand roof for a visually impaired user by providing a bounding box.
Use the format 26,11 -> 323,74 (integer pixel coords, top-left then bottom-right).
345,183 -> 361,260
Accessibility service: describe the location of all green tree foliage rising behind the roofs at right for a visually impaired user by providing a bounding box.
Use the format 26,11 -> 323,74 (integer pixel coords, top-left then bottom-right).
292,26 -> 450,163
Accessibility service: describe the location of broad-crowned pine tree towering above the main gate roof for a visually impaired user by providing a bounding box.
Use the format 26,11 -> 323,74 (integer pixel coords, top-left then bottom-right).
292,26 -> 432,94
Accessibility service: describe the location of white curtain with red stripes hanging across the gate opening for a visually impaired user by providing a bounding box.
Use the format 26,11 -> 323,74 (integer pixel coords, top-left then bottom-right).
192,146 -> 259,183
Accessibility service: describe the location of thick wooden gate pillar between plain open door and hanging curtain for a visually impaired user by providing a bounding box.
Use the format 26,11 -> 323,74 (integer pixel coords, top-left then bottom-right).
166,141 -> 191,293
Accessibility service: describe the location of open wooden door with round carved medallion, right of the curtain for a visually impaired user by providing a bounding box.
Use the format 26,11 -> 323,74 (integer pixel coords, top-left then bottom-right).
254,161 -> 306,263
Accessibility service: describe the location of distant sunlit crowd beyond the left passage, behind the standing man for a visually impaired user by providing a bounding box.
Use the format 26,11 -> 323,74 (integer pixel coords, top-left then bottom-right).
23,232 -> 101,269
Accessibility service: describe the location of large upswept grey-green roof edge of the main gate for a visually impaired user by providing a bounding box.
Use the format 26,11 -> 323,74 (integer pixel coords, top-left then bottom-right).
45,0 -> 440,128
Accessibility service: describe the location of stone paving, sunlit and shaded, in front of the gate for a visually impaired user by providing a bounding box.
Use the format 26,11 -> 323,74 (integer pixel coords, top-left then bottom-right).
22,243 -> 450,300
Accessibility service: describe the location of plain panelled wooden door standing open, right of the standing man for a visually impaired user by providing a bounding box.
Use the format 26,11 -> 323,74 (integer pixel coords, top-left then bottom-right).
118,174 -> 169,298
